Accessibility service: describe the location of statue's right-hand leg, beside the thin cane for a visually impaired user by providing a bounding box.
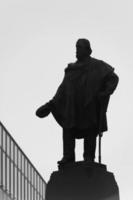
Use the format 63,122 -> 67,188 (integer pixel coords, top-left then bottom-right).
83,129 -> 97,162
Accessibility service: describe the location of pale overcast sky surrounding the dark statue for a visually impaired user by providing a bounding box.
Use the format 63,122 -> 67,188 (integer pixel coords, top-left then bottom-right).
0,0 -> 133,200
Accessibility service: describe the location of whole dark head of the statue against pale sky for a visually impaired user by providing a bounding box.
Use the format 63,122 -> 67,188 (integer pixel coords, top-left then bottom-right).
76,39 -> 92,61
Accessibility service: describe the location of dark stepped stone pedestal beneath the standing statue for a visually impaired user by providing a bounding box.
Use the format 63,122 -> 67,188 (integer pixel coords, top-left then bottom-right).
46,162 -> 119,200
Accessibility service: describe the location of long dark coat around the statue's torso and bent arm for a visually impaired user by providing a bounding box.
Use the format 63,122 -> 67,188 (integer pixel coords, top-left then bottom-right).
52,57 -> 118,137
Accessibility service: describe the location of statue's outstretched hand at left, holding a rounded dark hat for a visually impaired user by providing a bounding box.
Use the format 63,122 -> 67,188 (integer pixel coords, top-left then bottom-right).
36,103 -> 51,118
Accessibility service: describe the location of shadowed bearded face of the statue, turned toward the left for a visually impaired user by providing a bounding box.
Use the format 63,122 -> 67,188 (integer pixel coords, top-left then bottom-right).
76,41 -> 88,60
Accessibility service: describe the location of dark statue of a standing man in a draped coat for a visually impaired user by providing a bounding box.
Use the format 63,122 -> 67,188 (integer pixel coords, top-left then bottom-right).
36,39 -> 118,164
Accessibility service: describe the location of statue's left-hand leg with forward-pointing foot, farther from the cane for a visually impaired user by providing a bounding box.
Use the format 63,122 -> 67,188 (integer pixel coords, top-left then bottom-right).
58,128 -> 75,164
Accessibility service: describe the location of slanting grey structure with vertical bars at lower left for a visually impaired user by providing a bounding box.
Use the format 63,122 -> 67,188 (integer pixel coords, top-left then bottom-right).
0,122 -> 46,200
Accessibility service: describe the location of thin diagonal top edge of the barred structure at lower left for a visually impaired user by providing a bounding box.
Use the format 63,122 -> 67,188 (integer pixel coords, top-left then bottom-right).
0,121 -> 46,184
